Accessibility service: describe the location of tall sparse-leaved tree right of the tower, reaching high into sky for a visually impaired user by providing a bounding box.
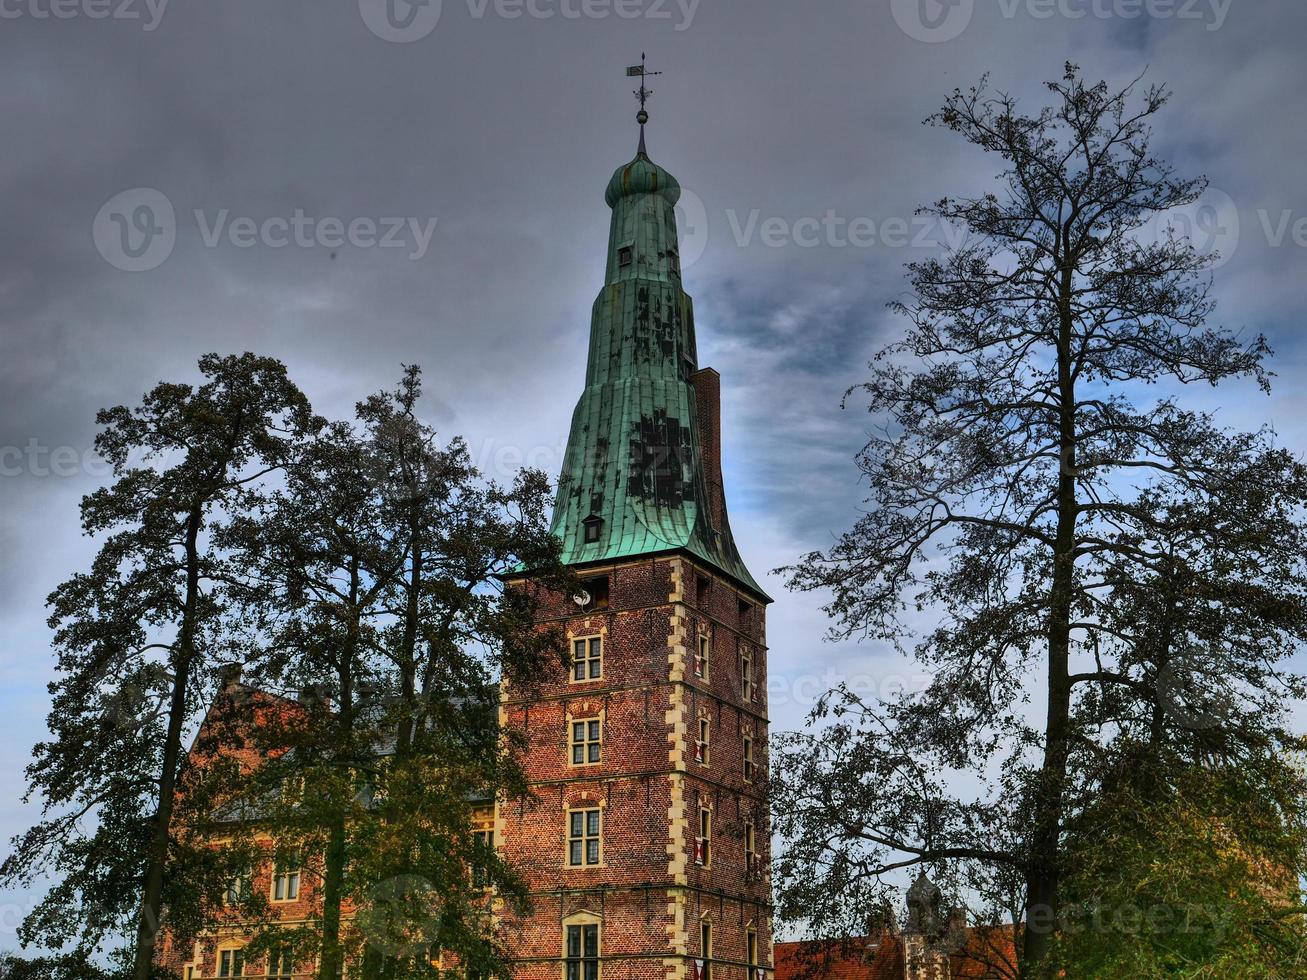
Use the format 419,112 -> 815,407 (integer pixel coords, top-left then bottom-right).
776,65 -> 1307,976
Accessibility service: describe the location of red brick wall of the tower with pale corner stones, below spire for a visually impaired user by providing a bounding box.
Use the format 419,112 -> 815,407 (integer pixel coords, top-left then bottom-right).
499,558 -> 771,980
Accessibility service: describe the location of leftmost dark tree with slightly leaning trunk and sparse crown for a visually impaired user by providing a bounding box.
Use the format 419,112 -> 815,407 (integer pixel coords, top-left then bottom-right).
0,354 -> 315,980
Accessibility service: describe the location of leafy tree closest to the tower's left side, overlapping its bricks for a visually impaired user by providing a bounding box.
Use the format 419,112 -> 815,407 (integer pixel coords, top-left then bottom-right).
347,367 -> 576,980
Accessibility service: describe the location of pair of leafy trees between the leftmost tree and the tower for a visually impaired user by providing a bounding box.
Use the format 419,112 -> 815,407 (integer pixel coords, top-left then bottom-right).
213,368 -> 569,980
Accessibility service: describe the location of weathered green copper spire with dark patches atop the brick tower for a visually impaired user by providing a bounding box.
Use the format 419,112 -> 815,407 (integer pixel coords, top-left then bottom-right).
553,96 -> 767,600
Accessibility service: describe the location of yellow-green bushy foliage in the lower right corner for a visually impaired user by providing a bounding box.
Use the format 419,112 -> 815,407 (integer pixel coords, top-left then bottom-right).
1053,743 -> 1307,980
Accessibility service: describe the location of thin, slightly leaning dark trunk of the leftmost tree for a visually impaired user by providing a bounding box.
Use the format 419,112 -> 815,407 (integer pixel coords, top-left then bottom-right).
132,506 -> 204,980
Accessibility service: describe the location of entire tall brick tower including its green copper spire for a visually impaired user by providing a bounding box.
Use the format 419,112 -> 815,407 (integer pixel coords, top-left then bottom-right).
495,103 -> 772,980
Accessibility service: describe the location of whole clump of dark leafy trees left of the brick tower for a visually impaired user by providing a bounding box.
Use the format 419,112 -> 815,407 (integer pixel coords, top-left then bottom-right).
3,354 -> 572,980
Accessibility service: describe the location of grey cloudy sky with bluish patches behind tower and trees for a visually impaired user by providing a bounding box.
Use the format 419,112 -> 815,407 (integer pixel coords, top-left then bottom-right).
0,0 -> 1307,945
